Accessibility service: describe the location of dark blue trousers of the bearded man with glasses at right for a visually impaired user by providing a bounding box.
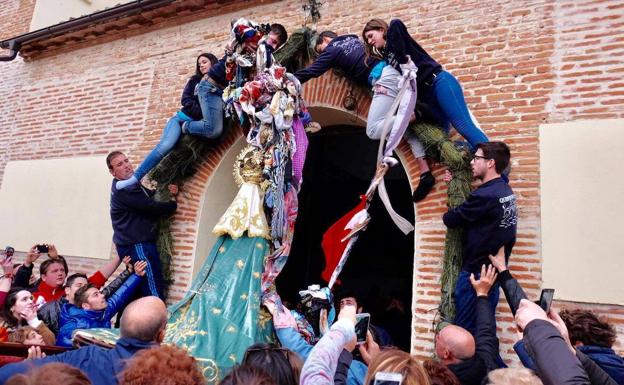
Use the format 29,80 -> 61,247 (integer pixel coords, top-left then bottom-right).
453,271 -> 500,335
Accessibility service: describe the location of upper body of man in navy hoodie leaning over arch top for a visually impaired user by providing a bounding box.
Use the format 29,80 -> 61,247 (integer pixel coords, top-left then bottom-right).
295,31 -> 379,87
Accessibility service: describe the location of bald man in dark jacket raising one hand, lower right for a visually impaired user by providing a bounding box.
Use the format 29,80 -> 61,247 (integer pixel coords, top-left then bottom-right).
435,265 -> 500,385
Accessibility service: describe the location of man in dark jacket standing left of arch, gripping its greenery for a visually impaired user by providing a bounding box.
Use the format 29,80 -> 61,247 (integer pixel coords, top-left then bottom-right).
106,151 -> 178,298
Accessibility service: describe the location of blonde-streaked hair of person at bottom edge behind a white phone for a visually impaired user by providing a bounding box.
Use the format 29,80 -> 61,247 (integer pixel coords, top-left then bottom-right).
364,349 -> 431,385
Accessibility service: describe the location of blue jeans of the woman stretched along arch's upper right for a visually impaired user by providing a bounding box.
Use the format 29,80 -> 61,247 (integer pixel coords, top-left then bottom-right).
418,71 -> 489,150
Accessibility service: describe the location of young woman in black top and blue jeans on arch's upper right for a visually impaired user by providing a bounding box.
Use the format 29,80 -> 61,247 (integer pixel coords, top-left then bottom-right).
362,19 -> 488,202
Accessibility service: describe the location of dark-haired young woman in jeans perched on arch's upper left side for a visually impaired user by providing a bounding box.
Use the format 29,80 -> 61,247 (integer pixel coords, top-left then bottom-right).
116,53 -> 223,189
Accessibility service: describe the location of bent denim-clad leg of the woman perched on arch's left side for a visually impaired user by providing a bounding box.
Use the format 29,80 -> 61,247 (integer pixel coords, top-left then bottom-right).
187,80 -> 223,138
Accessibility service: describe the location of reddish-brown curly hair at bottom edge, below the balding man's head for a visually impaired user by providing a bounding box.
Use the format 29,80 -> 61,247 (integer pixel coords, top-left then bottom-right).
119,345 -> 206,385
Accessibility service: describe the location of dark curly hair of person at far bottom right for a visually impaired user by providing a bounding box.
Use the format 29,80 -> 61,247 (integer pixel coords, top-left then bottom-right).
559,309 -> 617,348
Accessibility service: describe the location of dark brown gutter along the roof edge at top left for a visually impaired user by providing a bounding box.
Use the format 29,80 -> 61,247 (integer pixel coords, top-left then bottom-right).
0,0 -> 176,61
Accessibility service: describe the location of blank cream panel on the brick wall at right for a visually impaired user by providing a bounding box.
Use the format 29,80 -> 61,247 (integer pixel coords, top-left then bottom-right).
539,119 -> 624,305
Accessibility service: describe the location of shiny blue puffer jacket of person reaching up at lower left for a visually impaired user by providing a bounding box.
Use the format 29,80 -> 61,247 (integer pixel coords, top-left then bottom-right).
56,274 -> 141,347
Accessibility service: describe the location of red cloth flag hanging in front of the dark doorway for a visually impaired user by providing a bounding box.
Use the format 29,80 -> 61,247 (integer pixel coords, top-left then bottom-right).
321,195 -> 366,282
